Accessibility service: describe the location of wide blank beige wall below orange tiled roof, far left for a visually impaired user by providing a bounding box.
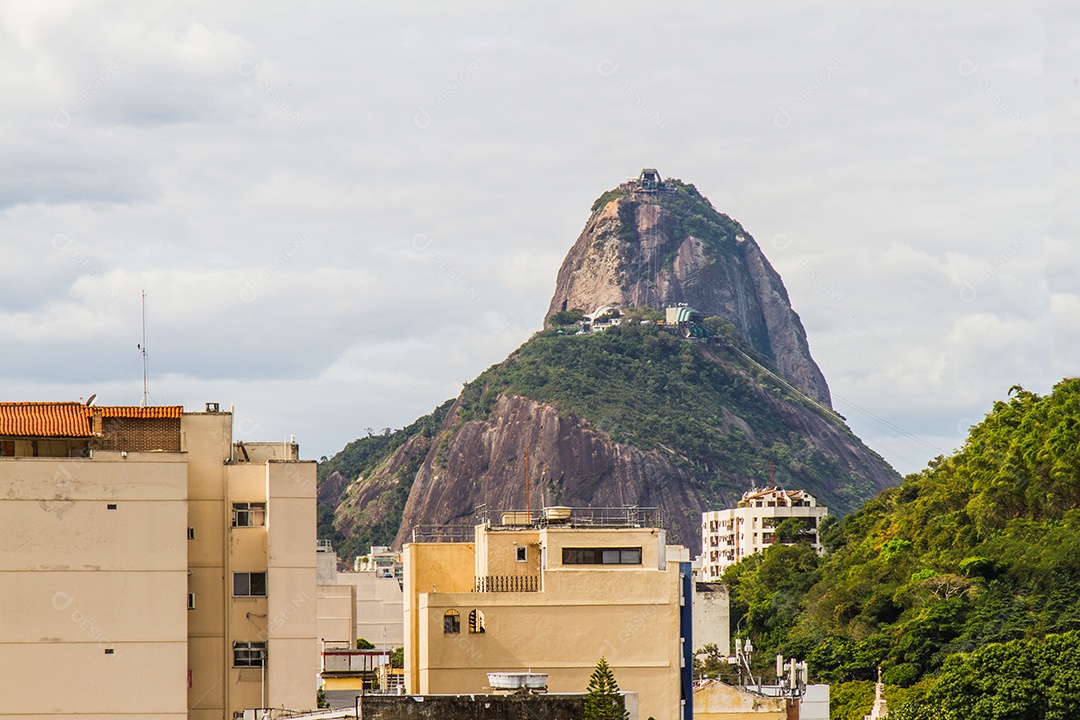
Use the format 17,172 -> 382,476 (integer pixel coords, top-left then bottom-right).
0,452 -> 188,720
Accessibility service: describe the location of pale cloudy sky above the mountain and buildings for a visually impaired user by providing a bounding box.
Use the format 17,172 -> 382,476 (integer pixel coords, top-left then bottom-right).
0,0 -> 1080,473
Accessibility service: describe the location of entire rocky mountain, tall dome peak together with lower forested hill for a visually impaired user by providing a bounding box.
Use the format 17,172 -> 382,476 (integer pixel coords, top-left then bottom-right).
320,172 -> 900,557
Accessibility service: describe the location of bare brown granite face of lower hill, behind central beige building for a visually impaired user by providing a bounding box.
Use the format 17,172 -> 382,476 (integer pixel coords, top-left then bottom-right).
395,395 -> 704,546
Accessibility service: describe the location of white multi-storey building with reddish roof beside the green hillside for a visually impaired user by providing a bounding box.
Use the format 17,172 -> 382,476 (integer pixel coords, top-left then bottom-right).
698,488 -> 828,583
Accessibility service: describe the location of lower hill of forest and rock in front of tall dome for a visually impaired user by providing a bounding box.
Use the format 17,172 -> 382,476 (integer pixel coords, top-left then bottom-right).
320,321 -> 900,557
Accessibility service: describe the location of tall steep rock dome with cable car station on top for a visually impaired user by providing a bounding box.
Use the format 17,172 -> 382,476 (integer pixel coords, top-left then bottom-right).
545,174 -> 829,405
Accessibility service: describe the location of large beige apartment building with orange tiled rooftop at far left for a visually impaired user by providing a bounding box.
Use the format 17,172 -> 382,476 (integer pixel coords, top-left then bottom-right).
0,403 -> 319,720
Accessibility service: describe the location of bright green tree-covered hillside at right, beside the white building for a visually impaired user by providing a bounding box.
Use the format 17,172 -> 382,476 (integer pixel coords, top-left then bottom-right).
725,380 -> 1080,718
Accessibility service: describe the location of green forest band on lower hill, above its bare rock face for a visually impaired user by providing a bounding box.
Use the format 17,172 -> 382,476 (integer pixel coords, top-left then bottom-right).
457,323 -> 873,513
